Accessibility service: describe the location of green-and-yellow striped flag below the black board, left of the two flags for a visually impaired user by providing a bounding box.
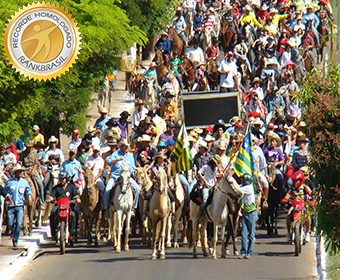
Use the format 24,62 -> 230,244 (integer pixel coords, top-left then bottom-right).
171,122 -> 192,177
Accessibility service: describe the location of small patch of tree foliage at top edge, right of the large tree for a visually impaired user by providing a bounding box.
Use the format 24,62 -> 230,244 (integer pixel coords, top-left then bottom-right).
120,0 -> 179,36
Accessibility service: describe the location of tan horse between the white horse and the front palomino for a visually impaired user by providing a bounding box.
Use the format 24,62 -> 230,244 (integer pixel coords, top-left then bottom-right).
135,167 -> 152,245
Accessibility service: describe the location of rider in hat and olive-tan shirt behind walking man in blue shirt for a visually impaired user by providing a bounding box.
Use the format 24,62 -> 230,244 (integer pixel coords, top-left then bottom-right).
18,140 -> 45,207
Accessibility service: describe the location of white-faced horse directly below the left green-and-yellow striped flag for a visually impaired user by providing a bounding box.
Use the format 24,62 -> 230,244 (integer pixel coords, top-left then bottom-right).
166,174 -> 184,248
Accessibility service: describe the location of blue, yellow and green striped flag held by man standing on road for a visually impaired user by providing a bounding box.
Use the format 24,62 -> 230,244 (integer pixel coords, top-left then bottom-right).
233,125 -> 254,177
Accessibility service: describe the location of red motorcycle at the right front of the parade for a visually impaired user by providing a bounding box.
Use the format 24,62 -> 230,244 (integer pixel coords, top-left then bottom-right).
291,198 -> 306,256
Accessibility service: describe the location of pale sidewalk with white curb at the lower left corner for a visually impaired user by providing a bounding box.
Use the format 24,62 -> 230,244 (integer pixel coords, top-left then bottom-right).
0,225 -> 50,280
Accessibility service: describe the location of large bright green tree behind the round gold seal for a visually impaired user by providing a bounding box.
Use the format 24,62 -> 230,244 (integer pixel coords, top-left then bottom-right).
0,0 -> 147,143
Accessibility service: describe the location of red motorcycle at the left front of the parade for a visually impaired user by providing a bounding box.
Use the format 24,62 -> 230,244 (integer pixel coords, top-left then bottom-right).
55,197 -> 74,254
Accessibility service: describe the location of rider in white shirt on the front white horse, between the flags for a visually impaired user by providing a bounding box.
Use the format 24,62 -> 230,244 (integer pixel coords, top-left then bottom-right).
198,154 -> 222,211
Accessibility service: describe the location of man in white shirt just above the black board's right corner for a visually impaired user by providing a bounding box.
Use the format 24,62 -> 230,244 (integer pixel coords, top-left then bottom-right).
217,51 -> 241,92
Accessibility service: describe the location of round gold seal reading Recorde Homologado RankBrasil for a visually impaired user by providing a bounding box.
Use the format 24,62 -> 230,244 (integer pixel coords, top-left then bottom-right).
3,2 -> 81,80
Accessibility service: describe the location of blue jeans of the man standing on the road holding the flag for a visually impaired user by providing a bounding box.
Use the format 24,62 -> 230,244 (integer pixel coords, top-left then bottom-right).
241,210 -> 257,256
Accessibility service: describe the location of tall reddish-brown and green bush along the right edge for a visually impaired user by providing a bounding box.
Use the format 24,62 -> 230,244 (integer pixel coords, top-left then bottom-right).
298,65 -> 340,253
